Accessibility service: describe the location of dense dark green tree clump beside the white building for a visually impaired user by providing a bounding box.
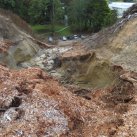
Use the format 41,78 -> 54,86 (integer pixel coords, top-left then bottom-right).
69,0 -> 116,32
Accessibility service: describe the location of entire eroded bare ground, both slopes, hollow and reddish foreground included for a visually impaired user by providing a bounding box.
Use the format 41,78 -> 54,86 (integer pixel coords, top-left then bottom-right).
0,6 -> 137,137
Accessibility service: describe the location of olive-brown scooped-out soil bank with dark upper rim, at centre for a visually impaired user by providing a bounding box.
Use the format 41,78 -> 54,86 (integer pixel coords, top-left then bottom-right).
58,52 -> 119,88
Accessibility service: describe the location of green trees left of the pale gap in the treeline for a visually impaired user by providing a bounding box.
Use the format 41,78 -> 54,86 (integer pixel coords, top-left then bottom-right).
0,0 -> 64,23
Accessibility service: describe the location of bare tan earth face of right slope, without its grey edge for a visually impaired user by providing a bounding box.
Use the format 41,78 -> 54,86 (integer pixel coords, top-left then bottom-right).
110,19 -> 137,71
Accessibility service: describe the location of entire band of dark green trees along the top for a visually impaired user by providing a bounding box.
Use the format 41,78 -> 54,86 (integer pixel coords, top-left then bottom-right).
0,0 -> 116,32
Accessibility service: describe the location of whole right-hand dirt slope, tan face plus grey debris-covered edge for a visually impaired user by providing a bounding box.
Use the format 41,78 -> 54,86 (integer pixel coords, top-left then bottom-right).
82,5 -> 137,71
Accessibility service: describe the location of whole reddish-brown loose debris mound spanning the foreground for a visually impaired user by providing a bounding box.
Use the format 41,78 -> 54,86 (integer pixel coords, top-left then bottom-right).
0,66 -> 137,137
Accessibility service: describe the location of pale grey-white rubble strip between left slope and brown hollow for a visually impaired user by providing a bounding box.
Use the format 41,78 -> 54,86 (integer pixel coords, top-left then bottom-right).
20,47 -> 72,71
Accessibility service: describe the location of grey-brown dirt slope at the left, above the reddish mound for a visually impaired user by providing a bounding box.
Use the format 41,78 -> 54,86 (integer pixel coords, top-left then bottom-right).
0,10 -> 39,68
